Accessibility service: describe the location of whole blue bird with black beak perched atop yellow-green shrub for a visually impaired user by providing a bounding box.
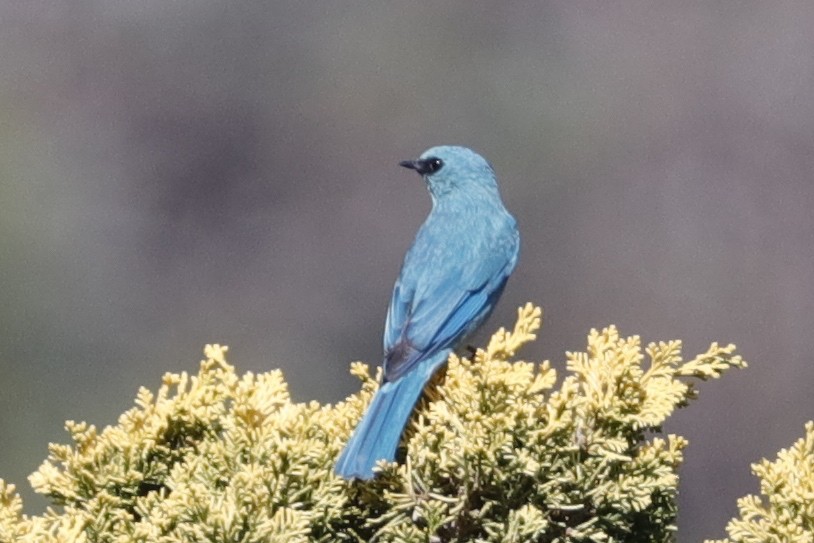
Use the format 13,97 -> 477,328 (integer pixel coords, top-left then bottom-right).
335,146 -> 520,479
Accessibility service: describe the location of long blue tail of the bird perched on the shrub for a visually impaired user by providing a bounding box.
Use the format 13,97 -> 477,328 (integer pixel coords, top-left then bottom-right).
334,351 -> 449,479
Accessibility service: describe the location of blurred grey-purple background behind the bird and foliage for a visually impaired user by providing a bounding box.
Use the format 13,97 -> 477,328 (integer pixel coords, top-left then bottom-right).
0,0 -> 814,542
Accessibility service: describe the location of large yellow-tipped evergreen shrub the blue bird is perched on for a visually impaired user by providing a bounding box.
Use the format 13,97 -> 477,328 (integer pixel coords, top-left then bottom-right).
0,305 -> 745,543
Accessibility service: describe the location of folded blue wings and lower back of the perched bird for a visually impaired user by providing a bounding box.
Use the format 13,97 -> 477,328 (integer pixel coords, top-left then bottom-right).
384,228 -> 518,381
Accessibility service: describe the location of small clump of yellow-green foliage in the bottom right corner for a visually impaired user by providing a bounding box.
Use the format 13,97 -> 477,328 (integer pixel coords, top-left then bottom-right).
708,421 -> 814,543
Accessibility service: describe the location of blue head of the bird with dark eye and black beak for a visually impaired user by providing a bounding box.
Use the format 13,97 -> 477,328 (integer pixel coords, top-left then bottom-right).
399,145 -> 497,199
